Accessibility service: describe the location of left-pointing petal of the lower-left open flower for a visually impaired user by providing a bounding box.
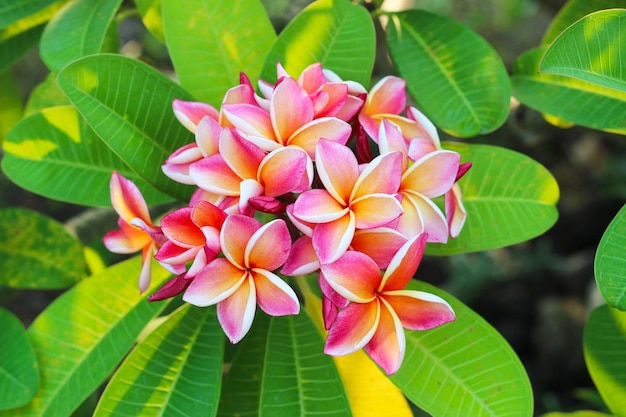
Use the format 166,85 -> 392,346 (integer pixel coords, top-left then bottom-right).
183,258 -> 248,307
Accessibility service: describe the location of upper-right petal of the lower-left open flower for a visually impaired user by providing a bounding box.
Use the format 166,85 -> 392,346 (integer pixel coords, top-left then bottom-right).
244,219 -> 291,271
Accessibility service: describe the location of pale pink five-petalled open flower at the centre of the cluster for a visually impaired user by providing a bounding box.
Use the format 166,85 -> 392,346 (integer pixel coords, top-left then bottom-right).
293,139 -> 402,263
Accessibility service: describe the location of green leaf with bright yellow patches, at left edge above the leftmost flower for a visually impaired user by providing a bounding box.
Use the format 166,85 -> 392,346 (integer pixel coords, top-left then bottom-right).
2,106 -> 172,207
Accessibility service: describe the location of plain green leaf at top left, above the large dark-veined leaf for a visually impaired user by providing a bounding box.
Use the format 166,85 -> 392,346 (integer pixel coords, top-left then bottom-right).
40,0 -> 122,72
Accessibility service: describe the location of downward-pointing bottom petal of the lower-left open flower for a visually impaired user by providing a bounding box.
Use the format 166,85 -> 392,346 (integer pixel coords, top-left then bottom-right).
217,276 -> 256,343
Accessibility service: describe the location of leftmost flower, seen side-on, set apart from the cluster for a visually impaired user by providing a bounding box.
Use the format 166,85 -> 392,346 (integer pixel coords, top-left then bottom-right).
102,172 -> 167,292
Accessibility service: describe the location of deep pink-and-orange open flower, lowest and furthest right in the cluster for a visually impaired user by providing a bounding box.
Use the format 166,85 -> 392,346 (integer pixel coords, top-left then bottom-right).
321,235 -> 455,374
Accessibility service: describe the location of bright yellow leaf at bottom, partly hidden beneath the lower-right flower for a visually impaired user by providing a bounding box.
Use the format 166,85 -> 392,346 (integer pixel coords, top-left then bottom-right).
296,277 -> 413,417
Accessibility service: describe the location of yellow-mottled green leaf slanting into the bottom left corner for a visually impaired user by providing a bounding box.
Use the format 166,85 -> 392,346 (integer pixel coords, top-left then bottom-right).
1,257 -> 169,417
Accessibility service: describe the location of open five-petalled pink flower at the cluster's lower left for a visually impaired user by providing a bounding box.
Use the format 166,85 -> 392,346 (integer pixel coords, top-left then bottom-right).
183,214 -> 300,343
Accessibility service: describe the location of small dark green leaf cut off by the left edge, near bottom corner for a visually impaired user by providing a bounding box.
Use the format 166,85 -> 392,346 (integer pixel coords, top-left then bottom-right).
0,307 -> 39,410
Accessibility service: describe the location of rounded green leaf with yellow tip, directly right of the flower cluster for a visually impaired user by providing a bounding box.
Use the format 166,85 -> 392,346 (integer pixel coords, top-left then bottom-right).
426,142 -> 559,255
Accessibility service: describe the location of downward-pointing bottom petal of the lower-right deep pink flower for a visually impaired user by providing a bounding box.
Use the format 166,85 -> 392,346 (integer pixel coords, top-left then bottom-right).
365,299 -> 406,375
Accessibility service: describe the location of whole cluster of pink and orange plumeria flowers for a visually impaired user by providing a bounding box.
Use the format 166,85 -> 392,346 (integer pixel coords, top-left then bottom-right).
104,64 -> 469,374
